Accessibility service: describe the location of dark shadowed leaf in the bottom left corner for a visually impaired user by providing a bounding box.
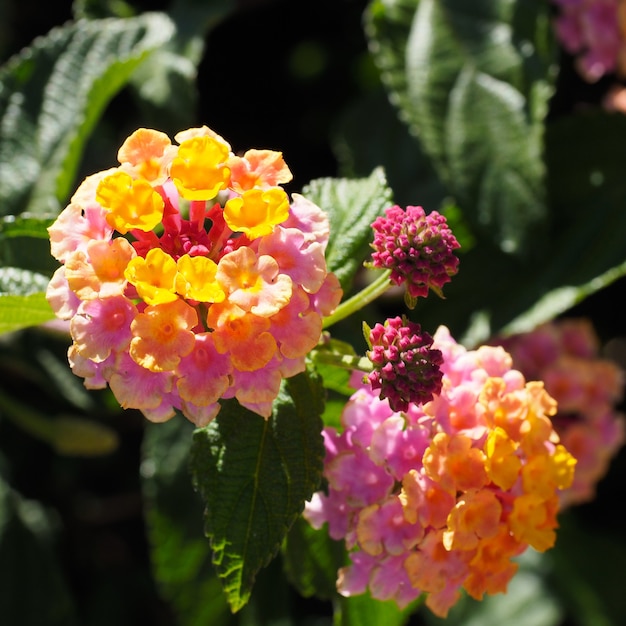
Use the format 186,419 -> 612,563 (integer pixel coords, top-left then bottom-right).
0,470 -> 78,626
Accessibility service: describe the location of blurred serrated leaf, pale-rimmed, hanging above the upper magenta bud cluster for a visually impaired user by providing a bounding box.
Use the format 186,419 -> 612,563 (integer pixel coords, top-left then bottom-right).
445,68 -> 546,252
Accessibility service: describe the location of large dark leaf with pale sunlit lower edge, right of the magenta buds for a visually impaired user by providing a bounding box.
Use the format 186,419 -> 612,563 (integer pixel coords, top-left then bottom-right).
416,112 -> 626,345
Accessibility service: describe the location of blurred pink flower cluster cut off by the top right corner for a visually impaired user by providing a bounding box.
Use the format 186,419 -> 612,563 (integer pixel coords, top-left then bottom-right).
554,0 -> 626,83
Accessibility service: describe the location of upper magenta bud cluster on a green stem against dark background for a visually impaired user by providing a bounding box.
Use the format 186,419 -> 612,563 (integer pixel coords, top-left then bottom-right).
372,205 -> 460,299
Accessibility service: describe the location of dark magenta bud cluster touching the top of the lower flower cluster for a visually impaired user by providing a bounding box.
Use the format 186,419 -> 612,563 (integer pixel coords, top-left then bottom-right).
367,317 -> 443,411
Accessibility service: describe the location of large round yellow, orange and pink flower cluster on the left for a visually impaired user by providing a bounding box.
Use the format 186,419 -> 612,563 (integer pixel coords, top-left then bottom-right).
47,127 -> 341,425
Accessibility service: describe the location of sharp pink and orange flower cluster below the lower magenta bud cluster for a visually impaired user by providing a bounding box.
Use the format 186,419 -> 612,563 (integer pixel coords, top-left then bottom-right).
305,326 -> 576,617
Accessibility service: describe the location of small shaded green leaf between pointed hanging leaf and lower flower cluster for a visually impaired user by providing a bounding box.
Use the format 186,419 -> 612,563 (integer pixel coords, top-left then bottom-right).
282,517 -> 347,600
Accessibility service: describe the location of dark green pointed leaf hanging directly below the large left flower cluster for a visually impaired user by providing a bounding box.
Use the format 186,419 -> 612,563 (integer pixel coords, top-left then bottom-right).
190,372 -> 324,611
